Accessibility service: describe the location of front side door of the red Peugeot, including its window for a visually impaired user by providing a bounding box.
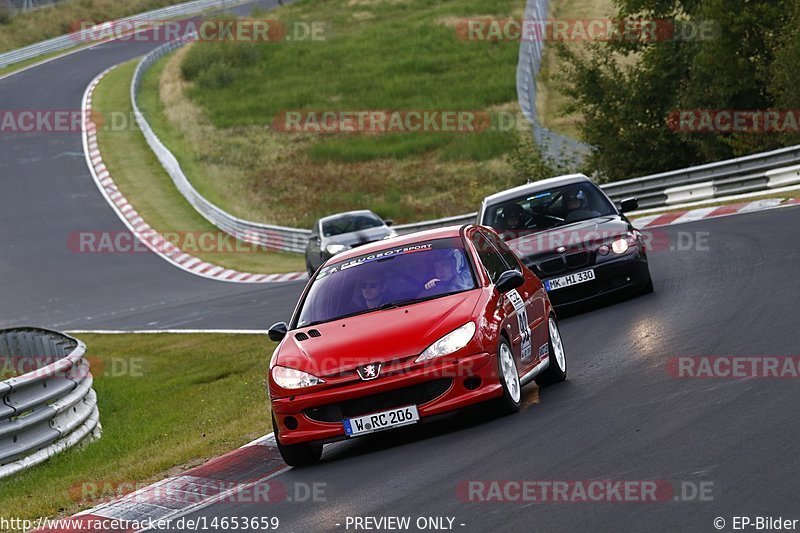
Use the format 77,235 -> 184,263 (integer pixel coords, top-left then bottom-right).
471,231 -> 533,375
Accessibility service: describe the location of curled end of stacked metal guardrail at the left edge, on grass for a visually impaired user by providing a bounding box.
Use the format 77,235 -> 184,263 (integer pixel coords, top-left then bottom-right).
0,328 -> 102,477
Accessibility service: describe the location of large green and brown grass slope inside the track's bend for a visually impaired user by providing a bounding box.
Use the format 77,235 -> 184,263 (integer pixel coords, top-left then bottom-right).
141,0 -> 528,227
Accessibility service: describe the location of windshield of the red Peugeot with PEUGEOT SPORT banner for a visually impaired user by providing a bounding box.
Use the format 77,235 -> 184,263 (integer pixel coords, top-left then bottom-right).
295,238 -> 476,327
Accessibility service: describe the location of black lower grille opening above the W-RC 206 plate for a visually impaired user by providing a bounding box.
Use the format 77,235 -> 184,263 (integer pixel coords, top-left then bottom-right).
303,378 -> 453,422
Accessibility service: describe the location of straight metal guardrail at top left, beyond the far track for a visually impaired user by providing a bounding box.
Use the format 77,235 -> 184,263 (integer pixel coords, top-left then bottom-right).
0,0 -> 253,68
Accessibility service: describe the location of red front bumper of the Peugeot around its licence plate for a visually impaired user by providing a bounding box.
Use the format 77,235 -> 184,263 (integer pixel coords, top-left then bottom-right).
272,353 -> 502,445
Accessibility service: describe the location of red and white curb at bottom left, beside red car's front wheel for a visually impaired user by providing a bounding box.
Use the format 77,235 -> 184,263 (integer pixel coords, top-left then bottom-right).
36,433 -> 289,533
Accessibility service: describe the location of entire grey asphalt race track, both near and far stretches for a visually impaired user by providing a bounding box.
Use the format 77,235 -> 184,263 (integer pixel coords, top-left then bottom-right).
0,2 -> 800,532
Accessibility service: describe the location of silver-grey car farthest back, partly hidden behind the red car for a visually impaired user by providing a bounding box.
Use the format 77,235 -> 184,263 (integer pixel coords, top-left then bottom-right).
306,210 -> 397,277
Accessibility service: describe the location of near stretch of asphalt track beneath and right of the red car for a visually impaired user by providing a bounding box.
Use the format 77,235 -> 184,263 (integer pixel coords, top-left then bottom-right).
152,208 -> 800,532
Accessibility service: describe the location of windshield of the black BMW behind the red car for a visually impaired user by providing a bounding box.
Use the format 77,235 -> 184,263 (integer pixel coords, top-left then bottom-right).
483,182 -> 617,240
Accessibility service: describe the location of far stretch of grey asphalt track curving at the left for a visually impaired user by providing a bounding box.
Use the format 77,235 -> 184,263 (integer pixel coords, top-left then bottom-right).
0,0 -> 303,330
